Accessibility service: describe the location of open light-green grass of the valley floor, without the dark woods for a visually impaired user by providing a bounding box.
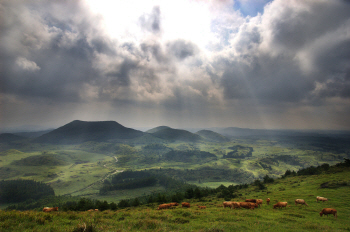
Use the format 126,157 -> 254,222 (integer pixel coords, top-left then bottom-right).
0,138 -> 346,201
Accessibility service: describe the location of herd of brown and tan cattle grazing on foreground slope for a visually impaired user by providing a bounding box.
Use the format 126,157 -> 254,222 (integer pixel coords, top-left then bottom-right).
43,196 -> 337,218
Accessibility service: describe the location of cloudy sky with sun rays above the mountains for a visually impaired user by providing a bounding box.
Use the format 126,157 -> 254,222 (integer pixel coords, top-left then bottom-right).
0,0 -> 350,131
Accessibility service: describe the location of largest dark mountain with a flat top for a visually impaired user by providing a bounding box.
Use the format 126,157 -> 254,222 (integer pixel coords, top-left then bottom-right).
34,120 -> 145,144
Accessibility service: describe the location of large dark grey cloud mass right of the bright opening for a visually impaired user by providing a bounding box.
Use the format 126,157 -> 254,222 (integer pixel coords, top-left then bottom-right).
212,1 -> 350,108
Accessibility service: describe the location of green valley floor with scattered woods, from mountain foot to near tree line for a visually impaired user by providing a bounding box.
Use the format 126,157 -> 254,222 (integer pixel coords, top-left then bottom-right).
0,135 -> 349,202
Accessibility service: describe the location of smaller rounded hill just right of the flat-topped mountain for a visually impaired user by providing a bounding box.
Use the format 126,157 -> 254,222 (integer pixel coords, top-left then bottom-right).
148,126 -> 202,142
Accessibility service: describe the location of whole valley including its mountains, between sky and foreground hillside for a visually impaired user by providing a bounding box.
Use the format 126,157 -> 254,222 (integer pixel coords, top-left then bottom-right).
0,120 -> 350,202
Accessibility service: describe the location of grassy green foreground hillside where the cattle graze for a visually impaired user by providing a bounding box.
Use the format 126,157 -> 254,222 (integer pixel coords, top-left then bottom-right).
0,168 -> 350,231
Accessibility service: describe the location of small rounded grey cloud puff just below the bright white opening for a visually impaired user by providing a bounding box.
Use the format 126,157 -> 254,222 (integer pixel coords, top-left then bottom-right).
168,39 -> 198,60
